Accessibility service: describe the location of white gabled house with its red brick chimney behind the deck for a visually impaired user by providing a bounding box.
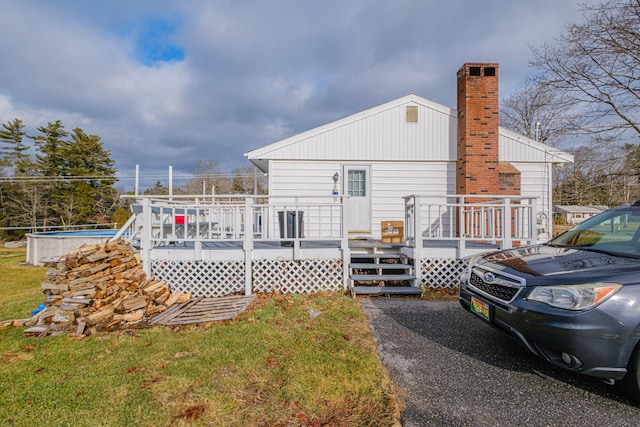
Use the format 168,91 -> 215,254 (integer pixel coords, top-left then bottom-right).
245,63 -> 573,238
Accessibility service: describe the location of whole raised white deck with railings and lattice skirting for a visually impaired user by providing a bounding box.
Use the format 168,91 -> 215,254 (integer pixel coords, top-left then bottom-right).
116,195 -> 537,297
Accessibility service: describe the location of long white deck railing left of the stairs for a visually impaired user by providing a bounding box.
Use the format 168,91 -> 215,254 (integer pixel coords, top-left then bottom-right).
115,195 -> 348,286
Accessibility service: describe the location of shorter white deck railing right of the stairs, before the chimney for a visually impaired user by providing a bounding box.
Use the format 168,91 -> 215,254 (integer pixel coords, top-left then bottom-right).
404,195 -> 538,258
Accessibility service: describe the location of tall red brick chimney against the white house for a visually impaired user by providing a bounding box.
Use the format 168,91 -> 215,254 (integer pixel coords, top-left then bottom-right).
456,63 -> 520,195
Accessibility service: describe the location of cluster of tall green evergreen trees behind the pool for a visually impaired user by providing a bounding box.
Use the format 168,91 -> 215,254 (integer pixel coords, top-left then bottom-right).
0,119 -> 120,239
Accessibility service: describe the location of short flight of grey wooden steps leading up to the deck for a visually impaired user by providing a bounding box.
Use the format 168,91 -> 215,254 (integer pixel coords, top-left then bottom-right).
349,245 -> 422,296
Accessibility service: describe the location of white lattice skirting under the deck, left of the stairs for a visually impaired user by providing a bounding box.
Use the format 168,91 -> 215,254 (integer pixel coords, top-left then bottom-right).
151,259 -> 343,297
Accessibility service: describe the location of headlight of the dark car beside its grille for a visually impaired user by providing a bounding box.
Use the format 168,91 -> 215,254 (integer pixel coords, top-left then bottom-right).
526,283 -> 622,310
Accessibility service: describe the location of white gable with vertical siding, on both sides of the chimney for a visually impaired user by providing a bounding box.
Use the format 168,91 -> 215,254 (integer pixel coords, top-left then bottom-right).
245,94 -> 573,172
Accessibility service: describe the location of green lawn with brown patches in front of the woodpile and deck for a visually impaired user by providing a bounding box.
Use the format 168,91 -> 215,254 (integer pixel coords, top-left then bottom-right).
0,249 -> 397,426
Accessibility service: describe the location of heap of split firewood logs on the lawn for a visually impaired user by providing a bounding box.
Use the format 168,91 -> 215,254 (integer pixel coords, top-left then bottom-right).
25,241 -> 191,336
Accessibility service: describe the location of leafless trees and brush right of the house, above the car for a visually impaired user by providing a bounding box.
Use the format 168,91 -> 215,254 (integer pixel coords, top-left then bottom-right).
528,0 -> 640,206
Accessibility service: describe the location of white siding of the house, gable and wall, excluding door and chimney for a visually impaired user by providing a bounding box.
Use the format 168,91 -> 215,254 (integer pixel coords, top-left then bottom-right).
247,95 -> 573,237
